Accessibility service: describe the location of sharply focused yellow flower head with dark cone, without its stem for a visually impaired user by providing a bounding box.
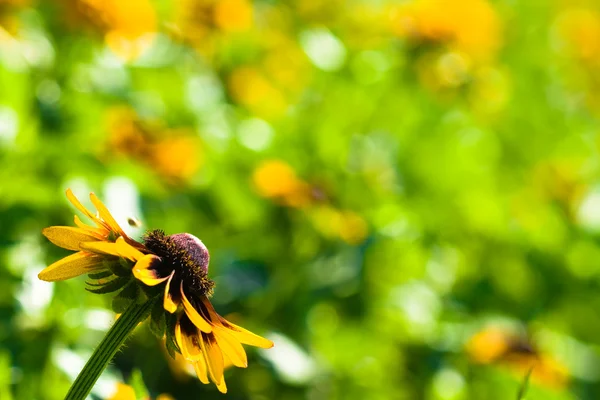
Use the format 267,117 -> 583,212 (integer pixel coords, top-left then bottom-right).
39,190 -> 273,393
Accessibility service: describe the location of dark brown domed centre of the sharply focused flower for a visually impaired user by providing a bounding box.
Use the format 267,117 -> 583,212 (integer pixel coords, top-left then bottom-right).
143,230 -> 214,298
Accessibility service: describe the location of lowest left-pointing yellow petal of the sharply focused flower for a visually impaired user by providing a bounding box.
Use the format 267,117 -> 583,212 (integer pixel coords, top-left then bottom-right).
38,251 -> 106,282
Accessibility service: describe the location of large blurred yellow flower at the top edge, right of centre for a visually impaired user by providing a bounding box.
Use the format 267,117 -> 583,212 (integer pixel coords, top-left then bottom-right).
389,0 -> 507,94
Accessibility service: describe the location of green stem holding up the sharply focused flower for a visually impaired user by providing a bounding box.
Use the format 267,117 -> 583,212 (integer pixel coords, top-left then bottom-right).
65,299 -> 157,400
